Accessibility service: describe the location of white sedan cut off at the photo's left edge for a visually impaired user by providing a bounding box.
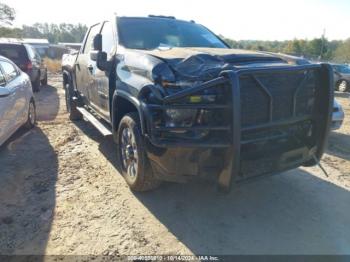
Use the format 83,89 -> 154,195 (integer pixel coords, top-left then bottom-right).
0,56 -> 36,145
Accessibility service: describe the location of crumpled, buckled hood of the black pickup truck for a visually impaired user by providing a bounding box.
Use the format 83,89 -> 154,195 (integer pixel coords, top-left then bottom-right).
120,48 -> 287,80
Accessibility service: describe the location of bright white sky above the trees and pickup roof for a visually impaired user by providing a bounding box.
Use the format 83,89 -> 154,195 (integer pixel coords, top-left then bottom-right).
1,0 -> 350,40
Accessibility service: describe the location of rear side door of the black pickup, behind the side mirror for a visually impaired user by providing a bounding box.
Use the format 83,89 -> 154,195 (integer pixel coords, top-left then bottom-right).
75,23 -> 101,105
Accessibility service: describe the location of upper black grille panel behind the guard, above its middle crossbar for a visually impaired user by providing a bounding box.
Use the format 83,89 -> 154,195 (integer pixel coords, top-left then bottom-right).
240,70 -> 318,128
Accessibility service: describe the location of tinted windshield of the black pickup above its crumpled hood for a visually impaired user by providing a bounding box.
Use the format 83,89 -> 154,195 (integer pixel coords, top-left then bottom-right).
118,17 -> 227,50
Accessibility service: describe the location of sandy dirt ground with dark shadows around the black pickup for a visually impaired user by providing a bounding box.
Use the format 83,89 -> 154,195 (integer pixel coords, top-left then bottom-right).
0,75 -> 350,255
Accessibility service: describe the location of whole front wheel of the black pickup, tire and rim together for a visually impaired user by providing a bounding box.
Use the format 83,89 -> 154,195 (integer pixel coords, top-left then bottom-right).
117,113 -> 160,191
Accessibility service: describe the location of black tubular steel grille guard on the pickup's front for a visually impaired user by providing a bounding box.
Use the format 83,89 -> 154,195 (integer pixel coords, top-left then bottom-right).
142,64 -> 334,190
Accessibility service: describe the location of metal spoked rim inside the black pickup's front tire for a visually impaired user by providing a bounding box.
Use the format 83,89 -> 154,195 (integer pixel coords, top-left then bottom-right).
120,127 -> 138,181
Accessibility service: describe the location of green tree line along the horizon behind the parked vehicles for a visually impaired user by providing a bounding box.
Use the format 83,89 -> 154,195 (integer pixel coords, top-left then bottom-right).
0,3 -> 350,63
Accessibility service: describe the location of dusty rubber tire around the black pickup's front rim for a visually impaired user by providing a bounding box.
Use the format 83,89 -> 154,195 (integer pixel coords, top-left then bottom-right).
117,112 -> 160,192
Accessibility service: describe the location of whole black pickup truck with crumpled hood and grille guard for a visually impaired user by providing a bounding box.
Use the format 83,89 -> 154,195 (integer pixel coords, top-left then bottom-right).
62,16 -> 333,191
